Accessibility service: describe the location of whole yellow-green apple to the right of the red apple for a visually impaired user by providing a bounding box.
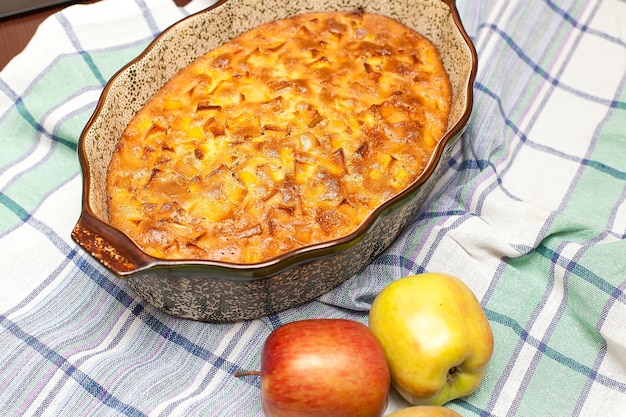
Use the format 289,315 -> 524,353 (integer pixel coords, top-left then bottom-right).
369,273 -> 493,405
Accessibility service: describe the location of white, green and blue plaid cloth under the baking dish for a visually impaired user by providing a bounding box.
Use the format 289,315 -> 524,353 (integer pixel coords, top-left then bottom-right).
0,0 -> 626,417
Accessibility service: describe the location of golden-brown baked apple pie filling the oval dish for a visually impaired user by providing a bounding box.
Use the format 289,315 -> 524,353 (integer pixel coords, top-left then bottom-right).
107,12 -> 451,263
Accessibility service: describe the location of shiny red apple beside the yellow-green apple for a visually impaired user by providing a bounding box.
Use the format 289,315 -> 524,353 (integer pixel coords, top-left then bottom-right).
261,319 -> 390,417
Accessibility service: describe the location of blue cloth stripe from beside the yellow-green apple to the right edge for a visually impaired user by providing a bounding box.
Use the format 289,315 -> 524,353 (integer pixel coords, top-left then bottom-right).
484,308 -> 626,392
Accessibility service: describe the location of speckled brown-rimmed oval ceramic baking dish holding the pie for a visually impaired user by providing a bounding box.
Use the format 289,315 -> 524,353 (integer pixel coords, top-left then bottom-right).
72,0 -> 477,322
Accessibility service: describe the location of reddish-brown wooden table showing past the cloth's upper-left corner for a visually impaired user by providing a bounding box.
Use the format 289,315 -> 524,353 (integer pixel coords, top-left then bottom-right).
0,0 -> 190,70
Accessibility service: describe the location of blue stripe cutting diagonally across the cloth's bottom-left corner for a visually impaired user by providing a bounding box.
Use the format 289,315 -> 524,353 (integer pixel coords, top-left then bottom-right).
0,314 -> 146,417
